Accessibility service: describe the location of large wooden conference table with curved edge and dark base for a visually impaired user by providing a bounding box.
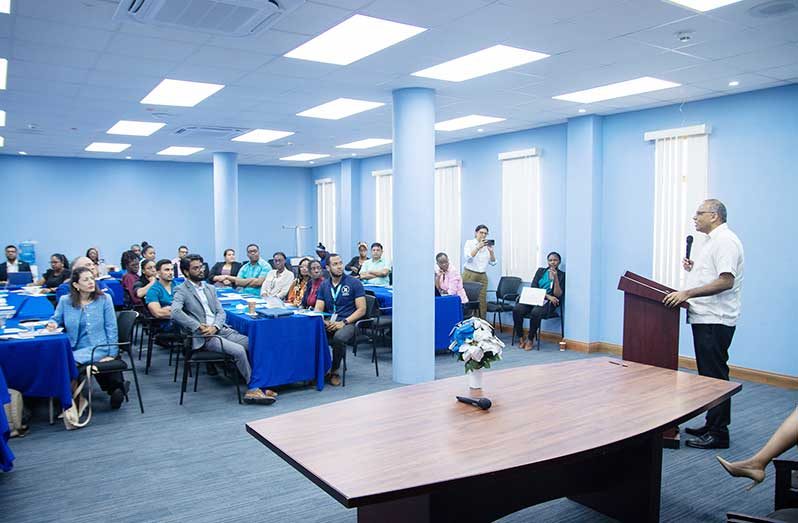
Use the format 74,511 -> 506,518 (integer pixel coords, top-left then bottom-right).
247,357 -> 742,523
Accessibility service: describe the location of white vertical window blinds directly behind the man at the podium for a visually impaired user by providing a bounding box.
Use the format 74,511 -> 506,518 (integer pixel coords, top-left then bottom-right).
645,125 -> 709,289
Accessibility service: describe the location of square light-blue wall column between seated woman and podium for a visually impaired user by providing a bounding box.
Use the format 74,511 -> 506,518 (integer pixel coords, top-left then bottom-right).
563,116 -> 603,348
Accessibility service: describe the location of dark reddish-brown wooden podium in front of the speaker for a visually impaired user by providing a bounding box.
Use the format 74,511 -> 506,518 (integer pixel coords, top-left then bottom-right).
618,271 -> 687,448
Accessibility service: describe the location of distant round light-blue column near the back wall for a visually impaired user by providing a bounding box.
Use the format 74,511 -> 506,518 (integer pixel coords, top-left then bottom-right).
213,153 -> 238,260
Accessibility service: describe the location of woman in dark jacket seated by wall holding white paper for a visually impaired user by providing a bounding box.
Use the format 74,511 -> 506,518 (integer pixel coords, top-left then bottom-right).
513,252 -> 565,350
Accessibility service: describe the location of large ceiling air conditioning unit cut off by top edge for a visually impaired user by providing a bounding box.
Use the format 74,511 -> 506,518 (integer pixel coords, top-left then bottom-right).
114,0 -> 305,36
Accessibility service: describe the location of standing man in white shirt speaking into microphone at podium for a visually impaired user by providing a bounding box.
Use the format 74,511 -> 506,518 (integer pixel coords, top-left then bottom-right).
663,200 -> 744,449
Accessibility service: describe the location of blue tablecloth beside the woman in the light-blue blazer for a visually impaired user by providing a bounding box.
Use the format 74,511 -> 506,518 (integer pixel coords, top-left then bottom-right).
0,320 -> 78,409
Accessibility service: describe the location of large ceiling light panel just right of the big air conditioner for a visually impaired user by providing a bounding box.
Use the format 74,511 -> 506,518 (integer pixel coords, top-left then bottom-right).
284,15 -> 426,65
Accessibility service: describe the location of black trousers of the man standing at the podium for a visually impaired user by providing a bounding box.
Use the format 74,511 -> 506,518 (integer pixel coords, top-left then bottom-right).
692,323 -> 735,439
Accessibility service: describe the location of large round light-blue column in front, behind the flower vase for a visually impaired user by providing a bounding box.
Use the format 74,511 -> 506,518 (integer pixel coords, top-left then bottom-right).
392,88 -> 435,383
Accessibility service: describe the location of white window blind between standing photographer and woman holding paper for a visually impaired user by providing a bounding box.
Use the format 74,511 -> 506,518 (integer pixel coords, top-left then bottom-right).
499,149 -> 540,281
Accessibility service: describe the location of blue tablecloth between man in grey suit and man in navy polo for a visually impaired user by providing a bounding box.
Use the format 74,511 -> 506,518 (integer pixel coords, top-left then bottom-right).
224,302 -> 332,390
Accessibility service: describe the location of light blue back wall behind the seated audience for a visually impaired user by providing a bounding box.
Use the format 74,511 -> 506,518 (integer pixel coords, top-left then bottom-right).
0,155 -> 315,269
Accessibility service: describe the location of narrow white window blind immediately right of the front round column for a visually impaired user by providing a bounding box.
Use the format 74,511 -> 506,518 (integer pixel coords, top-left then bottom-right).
433,162 -> 462,268
